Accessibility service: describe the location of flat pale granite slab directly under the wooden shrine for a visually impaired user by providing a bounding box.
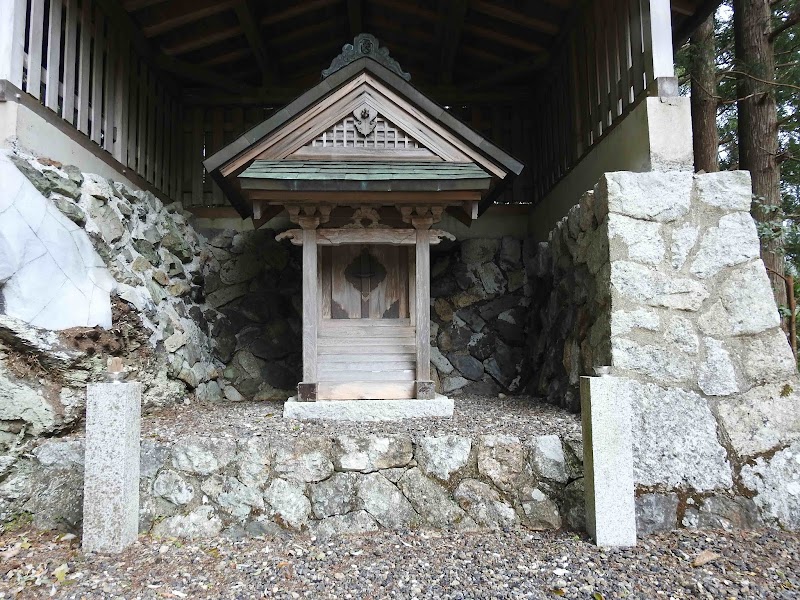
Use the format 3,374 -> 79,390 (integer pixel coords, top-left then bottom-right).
283,394 -> 453,421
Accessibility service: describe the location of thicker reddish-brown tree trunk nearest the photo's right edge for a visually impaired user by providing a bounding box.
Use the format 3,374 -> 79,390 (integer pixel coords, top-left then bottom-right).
733,0 -> 787,306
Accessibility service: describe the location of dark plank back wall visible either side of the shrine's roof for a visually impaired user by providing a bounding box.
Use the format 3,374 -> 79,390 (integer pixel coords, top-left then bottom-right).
181,103 -> 533,207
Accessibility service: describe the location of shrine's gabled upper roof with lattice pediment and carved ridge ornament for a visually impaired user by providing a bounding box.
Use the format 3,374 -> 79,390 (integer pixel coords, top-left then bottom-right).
204,34 -> 523,217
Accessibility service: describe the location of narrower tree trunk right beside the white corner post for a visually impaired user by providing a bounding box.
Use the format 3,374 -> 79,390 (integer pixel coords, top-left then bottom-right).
690,15 -> 719,173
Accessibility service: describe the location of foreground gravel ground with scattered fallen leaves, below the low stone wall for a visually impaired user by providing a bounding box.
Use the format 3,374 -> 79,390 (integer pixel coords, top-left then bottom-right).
0,530 -> 800,600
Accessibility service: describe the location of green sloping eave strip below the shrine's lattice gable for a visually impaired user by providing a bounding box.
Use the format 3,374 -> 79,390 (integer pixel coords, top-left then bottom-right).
238,160 -> 491,191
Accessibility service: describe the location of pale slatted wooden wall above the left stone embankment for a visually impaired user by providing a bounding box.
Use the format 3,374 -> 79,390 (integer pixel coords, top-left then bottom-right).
22,0 -> 183,199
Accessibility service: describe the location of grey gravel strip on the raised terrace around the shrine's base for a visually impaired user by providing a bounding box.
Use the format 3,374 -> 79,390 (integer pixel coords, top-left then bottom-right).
61,396 -> 581,441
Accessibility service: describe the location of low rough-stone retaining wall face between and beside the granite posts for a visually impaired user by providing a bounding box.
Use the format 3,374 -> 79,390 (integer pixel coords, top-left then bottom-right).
0,435 -> 584,538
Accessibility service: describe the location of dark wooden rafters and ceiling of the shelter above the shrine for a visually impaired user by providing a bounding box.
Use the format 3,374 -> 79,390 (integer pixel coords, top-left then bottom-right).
119,0 -> 720,104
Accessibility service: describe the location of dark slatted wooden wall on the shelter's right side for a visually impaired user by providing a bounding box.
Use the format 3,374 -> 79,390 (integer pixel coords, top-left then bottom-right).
528,0 -> 654,202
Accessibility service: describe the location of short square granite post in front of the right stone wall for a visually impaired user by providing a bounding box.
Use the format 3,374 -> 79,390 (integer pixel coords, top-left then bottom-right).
581,376 -> 636,546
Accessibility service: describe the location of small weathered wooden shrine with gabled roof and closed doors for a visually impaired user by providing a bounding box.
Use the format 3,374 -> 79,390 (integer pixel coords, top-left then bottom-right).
205,34 -> 522,401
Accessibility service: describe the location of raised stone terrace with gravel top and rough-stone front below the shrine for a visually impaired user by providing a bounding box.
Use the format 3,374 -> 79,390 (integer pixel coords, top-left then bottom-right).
0,398 -> 583,538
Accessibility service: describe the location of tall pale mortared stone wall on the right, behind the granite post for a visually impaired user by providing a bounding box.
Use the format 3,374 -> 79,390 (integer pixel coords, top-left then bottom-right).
526,172 -> 800,533
